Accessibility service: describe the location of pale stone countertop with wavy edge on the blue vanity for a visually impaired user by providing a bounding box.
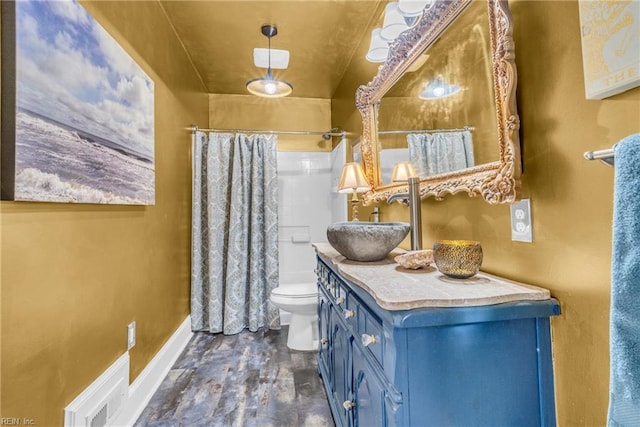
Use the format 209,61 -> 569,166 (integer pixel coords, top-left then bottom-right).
313,243 -> 551,310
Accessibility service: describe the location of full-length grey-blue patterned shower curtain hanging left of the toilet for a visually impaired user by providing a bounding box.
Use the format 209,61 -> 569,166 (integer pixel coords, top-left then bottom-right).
191,132 -> 280,334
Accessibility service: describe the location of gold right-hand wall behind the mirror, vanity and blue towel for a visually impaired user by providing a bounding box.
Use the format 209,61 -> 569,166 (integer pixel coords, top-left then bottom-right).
333,0 -> 640,426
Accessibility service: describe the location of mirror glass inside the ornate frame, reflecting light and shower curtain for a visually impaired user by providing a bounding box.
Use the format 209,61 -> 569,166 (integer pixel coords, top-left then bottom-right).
378,2 -> 498,185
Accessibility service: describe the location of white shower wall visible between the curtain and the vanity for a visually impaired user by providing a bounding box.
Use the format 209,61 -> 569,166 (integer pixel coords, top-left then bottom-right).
278,143 -> 346,284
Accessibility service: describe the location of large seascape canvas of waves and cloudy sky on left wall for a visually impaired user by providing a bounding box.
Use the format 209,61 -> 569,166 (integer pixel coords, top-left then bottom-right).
1,0 -> 155,205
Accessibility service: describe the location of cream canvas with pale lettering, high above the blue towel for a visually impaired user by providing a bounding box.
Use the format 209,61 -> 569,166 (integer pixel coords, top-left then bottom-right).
579,0 -> 640,99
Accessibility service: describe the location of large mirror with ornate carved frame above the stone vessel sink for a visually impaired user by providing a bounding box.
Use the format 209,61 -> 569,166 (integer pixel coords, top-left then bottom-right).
356,0 -> 521,204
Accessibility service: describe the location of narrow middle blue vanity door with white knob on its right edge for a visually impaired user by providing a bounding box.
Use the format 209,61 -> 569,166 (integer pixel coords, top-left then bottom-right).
329,306 -> 353,426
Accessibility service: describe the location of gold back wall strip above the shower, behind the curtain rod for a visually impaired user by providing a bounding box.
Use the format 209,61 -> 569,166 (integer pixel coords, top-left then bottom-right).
209,94 -> 337,151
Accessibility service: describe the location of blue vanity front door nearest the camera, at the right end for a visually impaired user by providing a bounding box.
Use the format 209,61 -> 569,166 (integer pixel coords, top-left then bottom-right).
353,343 -> 388,427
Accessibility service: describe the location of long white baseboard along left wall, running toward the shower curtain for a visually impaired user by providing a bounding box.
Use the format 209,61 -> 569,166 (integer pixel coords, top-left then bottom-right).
113,316 -> 193,427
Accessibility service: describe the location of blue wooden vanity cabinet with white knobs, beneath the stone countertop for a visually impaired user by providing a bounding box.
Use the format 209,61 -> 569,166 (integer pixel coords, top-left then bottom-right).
318,253 -> 559,427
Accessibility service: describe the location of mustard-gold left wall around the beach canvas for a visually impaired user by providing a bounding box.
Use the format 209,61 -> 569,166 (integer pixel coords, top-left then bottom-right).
0,1 -> 208,426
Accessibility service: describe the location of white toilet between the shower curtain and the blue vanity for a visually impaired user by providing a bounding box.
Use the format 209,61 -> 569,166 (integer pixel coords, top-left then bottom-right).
271,283 -> 318,351
